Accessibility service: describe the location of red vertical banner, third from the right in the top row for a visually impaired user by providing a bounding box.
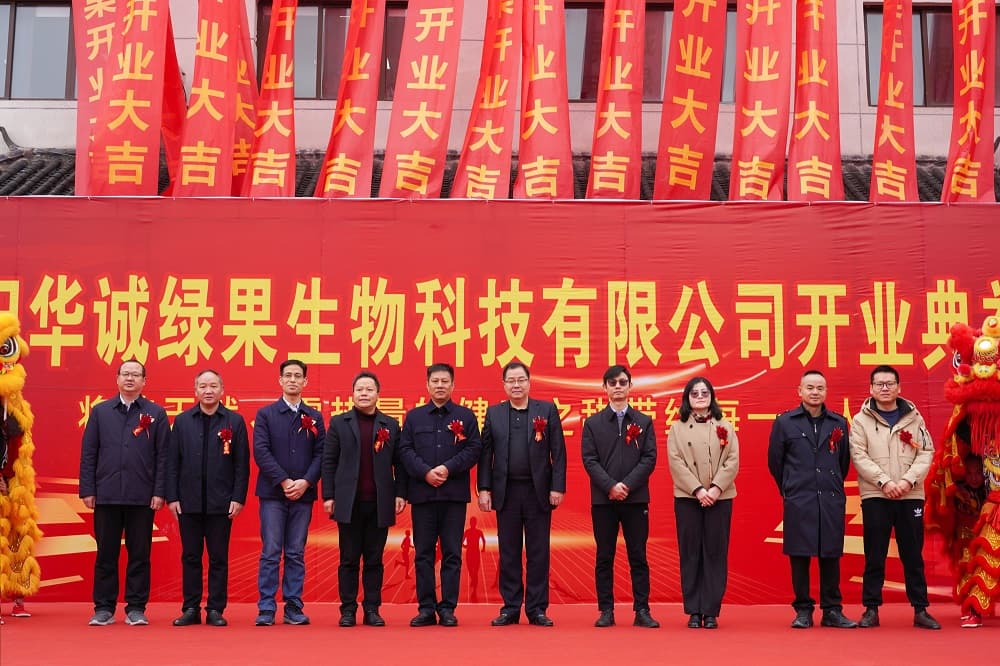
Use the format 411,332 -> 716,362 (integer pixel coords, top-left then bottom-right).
788,0 -> 844,201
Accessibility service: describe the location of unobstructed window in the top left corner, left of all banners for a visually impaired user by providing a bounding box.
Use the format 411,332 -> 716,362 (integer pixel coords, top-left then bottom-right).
0,0 -> 76,99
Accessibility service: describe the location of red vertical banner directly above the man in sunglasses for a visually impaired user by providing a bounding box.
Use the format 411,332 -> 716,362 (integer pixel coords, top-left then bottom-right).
587,0 -> 646,199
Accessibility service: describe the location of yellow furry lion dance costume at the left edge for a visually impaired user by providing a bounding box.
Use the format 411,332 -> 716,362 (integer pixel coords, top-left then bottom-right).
0,312 -> 42,599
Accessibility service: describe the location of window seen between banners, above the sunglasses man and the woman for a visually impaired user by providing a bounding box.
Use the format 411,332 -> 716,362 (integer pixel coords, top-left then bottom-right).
566,3 -> 736,103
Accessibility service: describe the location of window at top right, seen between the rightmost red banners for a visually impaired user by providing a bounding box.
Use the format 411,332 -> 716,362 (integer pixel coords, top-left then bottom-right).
865,5 -> 1000,106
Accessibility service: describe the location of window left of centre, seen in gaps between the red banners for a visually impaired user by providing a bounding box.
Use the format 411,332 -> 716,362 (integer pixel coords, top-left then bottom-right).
257,0 -> 406,100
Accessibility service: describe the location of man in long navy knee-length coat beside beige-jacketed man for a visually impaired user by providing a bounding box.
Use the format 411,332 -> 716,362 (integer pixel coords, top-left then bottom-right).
767,370 -> 858,629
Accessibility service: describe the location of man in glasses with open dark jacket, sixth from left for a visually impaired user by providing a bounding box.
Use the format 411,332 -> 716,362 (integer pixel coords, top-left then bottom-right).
477,361 -> 566,627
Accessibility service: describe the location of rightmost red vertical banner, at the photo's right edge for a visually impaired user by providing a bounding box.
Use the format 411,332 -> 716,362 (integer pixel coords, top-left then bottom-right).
941,0 -> 997,202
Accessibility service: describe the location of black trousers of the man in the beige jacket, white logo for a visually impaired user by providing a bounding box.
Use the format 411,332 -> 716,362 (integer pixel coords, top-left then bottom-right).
861,497 -> 930,611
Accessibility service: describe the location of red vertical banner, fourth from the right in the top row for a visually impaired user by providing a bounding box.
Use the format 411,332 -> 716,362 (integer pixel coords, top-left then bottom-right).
729,0 -> 793,201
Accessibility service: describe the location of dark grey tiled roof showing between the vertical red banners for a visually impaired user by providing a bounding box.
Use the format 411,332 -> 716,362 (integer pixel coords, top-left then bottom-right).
0,146 -> 1000,202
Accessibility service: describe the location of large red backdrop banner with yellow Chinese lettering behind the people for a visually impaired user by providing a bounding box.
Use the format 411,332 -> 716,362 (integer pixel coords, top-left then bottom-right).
0,198 -> 1000,603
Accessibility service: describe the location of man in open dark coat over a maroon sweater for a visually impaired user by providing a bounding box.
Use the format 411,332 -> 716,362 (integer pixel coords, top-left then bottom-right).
323,372 -> 406,627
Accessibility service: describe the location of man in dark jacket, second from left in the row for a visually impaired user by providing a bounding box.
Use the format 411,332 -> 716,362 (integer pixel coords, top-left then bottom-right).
167,370 -> 250,627
